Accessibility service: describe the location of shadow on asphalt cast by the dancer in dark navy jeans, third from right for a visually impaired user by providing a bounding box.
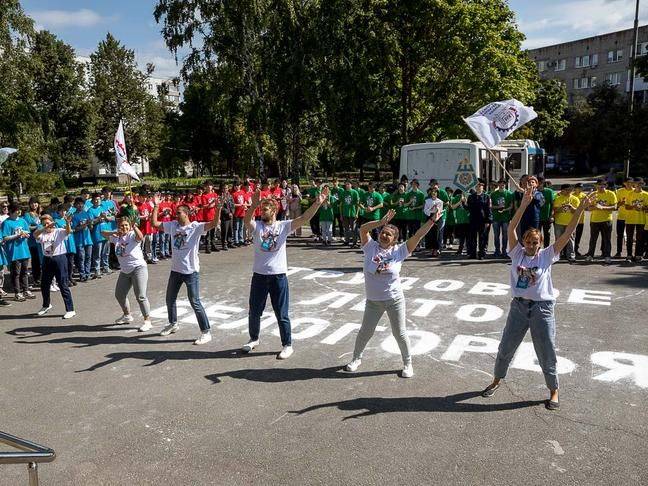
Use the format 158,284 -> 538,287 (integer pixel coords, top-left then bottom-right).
77,341 -> 277,373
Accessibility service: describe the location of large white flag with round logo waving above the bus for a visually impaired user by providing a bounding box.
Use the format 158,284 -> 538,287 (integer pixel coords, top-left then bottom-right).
464,99 -> 538,149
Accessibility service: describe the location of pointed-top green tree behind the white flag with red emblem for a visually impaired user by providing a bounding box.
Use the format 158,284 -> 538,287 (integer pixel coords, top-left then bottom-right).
90,33 -> 164,166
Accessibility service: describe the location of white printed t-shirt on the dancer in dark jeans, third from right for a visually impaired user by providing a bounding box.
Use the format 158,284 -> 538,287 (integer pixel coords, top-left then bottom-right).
251,220 -> 292,275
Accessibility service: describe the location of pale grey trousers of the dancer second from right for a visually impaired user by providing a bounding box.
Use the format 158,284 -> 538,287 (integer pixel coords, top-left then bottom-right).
353,296 -> 412,364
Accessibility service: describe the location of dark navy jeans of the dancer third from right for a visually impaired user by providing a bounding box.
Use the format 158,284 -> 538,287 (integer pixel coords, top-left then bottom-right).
248,273 -> 292,346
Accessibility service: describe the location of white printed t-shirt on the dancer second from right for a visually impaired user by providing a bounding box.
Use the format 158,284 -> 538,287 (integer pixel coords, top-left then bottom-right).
362,239 -> 409,300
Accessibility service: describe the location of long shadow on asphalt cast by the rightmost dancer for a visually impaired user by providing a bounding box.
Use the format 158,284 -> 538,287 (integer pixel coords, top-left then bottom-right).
290,391 -> 545,420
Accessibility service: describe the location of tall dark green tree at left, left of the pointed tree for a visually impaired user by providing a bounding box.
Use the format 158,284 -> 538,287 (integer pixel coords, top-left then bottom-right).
32,31 -> 93,174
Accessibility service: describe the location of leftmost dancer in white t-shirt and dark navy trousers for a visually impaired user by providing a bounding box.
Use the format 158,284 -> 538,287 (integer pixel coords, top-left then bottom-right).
34,214 -> 76,319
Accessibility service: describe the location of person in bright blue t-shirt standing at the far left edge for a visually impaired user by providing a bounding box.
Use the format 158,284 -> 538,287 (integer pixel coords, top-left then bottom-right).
2,203 -> 36,302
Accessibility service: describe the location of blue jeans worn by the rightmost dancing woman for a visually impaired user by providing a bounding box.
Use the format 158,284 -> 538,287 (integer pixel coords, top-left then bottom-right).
494,297 -> 558,390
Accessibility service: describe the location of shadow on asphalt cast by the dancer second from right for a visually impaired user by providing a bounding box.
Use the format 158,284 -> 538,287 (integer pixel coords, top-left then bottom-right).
205,366 -> 397,383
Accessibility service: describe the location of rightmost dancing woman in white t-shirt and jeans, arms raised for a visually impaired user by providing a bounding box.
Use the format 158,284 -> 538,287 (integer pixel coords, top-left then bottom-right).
482,187 -> 593,410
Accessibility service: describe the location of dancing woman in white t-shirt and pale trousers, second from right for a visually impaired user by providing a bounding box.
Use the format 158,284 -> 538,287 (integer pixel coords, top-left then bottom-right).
345,209 -> 441,378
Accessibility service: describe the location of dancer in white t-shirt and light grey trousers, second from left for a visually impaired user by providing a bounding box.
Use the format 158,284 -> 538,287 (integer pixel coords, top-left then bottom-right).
101,218 -> 153,332
